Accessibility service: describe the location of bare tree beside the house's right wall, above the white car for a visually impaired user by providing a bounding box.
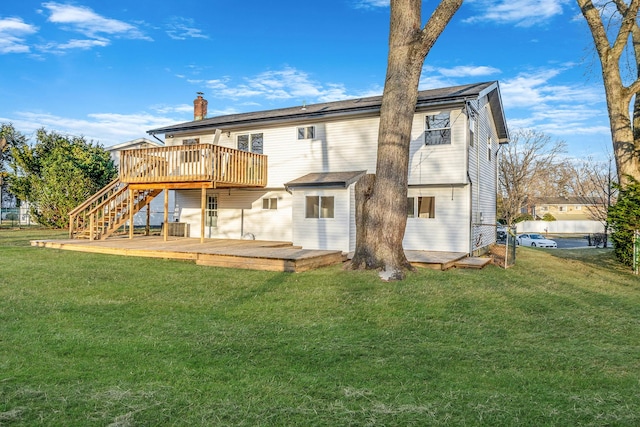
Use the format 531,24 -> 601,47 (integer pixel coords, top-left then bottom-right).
498,129 -> 568,225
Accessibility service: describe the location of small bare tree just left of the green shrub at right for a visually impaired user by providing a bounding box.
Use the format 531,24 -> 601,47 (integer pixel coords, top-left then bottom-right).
573,156 -> 618,248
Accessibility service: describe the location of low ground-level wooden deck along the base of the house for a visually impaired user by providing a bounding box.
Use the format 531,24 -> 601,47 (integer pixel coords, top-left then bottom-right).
31,236 -> 490,272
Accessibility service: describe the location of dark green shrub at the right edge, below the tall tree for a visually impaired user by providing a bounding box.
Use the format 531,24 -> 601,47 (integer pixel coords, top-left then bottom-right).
609,178 -> 640,266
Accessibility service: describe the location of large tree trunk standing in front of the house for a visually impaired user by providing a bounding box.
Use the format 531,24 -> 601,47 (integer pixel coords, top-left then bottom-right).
351,0 -> 462,280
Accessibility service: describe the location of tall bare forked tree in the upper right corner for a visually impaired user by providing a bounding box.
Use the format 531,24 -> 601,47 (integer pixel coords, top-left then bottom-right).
576,0 -> 640,185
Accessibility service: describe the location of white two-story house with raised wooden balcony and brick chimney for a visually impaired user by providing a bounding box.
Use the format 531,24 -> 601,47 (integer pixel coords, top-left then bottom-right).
69,82 -> 509,253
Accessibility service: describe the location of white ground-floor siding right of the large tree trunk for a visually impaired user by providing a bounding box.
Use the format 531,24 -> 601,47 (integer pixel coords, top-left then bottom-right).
402,186 -> 469,253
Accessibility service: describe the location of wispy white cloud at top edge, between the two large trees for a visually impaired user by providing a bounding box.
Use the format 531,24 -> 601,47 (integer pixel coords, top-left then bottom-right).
465,0 -> 569,27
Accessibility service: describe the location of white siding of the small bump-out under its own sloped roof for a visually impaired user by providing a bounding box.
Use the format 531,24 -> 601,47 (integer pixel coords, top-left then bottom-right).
293,189 -> 355,252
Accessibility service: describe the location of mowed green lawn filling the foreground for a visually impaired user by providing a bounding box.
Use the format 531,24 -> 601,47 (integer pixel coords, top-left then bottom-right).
0,230 -> 640,426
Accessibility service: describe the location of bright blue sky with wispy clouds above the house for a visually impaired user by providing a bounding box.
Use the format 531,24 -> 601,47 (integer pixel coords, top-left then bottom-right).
0,0 -> 611,158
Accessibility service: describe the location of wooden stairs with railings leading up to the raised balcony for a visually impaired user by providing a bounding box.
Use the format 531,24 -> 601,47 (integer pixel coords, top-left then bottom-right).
69,179 -> 162,240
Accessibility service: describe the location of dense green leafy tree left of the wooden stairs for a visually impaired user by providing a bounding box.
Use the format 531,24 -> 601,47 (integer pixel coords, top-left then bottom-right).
10,125 -> 117,228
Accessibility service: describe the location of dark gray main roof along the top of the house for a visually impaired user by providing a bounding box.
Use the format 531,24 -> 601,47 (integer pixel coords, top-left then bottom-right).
147,81 -> 509,142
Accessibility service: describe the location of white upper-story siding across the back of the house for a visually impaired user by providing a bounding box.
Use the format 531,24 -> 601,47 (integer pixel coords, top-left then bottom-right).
167,109 -> 467,187
